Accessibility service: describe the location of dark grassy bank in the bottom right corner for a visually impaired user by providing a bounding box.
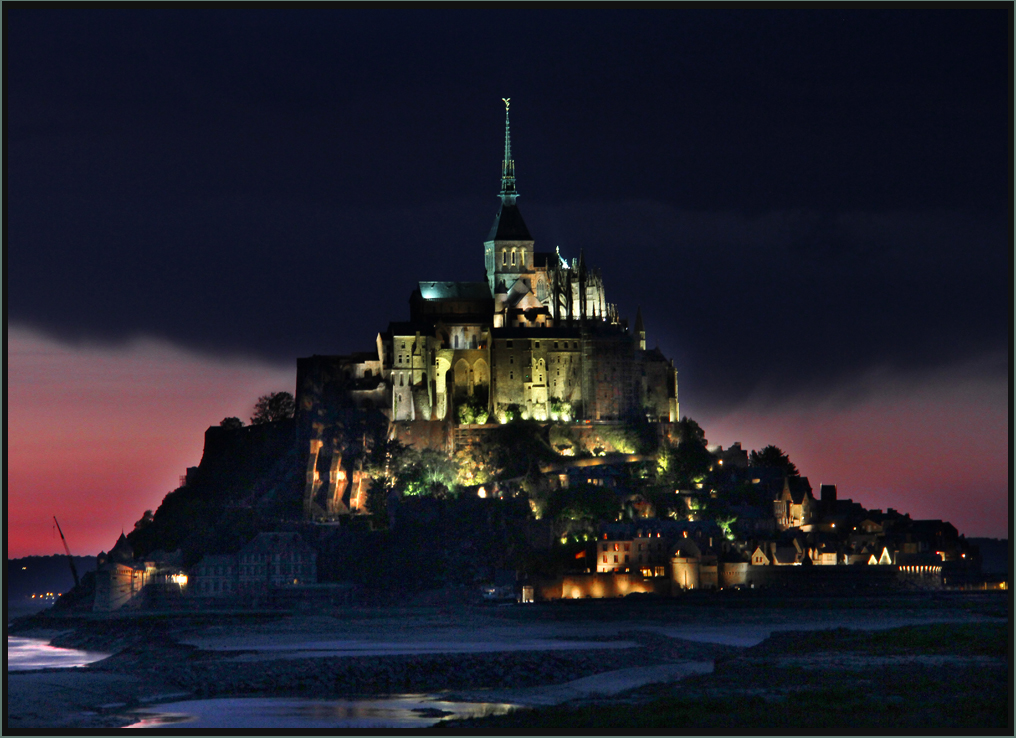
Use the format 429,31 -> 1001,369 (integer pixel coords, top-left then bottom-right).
440,623 -> 1012,735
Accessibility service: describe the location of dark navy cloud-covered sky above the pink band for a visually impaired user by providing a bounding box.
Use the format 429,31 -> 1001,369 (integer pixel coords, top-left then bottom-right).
4,5 -> 1012,409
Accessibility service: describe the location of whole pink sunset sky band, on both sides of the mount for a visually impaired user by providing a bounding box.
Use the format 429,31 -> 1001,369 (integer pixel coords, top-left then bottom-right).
7,326 -> 1009,557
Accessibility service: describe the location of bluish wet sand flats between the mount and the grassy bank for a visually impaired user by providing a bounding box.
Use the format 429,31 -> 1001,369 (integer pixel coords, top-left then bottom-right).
6,597 -> 1001,730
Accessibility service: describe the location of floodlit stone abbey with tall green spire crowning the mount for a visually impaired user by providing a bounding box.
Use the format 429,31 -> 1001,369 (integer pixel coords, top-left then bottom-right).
297,100 -> 679,514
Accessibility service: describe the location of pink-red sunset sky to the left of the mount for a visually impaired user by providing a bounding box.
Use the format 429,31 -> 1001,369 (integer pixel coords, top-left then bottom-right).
7,326 -> 296,558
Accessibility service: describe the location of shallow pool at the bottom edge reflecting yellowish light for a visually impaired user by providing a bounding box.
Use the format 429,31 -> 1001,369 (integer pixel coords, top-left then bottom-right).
127,694 -> 517,730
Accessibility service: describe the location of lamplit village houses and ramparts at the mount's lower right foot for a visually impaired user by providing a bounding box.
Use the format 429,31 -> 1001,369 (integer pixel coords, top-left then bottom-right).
526,465 -> 978,600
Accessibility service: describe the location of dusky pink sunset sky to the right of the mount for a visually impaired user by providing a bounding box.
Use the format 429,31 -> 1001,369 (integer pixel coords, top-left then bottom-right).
696,359 -> 1010,538
